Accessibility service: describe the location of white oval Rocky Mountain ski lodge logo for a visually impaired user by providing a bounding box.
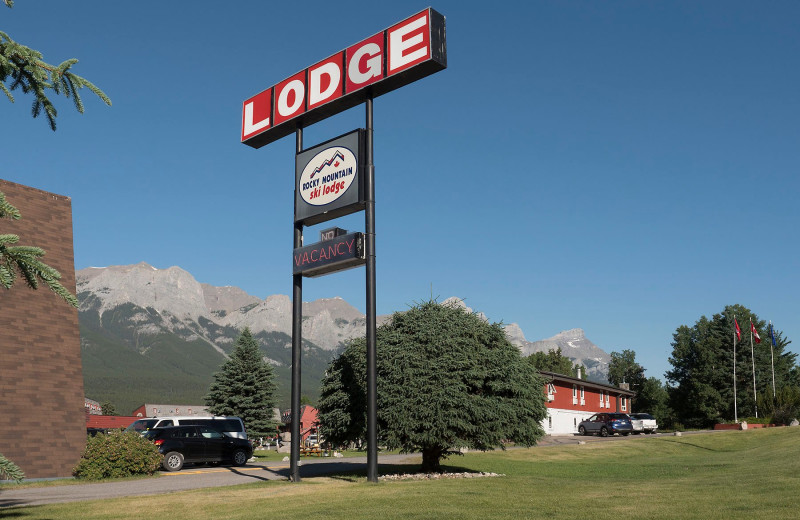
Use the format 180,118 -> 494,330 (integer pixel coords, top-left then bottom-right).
298,146 -> 358,206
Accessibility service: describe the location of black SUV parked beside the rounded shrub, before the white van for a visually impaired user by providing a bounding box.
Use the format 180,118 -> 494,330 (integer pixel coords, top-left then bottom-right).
143,426 -> 253,471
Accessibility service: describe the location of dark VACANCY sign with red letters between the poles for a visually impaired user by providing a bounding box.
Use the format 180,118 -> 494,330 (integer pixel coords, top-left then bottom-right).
292,233 -> 366,278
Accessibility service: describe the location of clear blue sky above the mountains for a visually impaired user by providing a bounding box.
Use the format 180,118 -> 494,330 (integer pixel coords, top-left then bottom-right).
0,0 -> 800,377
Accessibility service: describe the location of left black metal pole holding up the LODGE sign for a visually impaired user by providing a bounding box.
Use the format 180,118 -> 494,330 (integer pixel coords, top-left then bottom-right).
289,127 -> 303,482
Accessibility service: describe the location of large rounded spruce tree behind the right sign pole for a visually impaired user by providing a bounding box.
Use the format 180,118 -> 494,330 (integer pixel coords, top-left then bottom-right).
319,301 -> 546,471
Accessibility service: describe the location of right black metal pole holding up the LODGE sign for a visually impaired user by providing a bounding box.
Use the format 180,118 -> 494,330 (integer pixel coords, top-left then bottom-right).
364,96 -> 378,482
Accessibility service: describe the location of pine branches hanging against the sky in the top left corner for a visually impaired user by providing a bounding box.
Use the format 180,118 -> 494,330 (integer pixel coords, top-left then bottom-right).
0,0 -> 111,131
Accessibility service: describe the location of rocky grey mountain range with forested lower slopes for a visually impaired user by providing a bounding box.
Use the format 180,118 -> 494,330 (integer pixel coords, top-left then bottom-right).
76,262 -> 610,414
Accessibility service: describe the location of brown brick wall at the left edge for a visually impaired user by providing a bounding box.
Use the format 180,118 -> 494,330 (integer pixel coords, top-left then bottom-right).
0,179 -> 86,478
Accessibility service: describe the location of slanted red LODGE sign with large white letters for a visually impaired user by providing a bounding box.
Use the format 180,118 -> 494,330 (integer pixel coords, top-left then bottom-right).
241,8 -> 447,148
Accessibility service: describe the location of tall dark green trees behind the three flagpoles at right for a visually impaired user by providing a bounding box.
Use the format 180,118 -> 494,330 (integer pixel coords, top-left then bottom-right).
666,305 -> 797,427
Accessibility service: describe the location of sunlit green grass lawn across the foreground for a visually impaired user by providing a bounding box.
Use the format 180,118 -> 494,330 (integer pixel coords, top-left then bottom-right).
2,428 -> 800,520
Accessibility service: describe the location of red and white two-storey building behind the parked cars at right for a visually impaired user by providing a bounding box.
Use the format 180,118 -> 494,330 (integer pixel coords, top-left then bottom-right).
539,372 -> 636,435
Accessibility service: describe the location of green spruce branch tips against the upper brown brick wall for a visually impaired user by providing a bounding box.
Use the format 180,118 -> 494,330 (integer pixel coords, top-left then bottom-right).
0,192 -> 78,307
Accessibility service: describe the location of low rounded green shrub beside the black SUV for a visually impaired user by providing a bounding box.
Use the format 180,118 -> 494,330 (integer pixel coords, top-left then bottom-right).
72,431 -> 162,480
